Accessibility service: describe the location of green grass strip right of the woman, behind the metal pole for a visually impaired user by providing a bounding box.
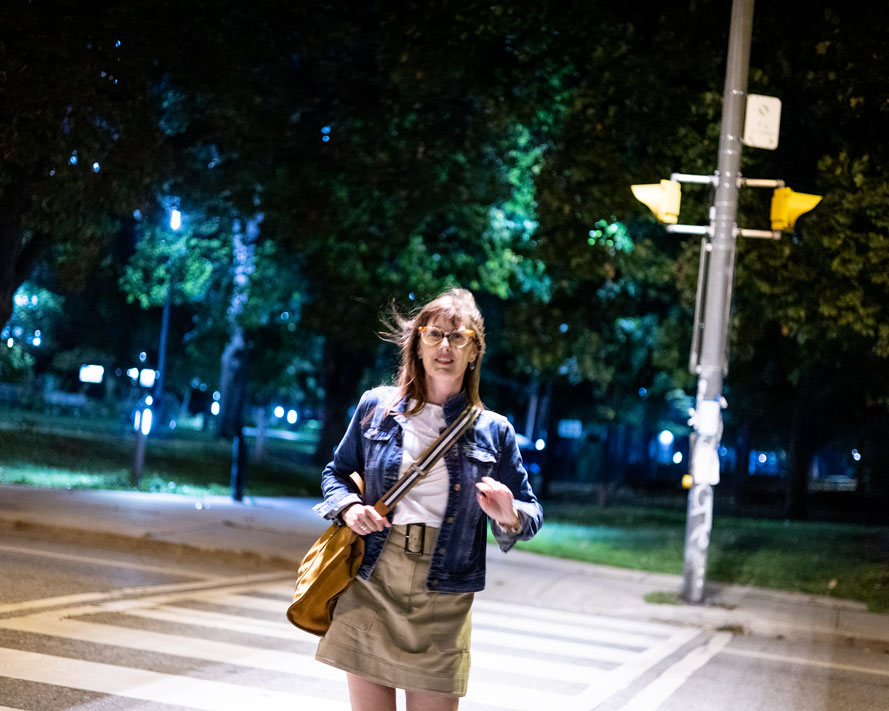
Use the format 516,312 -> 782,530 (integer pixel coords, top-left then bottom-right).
510,503 -> 889,612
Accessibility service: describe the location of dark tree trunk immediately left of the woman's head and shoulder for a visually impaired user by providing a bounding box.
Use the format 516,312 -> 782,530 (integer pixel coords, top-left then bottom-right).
314,336 -> 373,466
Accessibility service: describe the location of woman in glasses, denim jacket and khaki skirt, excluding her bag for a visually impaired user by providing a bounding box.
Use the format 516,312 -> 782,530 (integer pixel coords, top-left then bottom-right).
316,289 -> 543,711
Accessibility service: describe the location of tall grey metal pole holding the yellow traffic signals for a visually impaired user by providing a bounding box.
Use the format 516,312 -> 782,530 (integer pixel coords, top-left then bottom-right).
682,0 -> 753,603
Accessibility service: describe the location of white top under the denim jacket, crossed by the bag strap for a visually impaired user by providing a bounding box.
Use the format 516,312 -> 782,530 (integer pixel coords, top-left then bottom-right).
392,403 -> 449,528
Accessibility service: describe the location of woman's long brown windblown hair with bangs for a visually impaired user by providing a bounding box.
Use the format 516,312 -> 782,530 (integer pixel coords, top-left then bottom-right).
383,288 -> 485,415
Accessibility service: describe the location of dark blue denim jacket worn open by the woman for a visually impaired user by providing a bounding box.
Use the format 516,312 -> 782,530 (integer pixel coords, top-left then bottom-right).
315,387 -> 543,593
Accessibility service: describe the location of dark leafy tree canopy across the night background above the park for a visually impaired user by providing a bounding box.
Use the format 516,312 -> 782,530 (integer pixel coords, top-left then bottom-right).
0,0 -> 889,512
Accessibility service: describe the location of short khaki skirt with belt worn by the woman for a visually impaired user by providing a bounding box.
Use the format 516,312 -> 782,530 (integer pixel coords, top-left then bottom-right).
315,525 -> 474,696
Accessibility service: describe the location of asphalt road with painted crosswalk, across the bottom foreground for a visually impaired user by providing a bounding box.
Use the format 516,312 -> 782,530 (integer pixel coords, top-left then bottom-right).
0,531 -> 889,711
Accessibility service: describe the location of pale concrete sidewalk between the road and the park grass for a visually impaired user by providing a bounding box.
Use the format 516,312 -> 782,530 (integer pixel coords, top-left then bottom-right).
0,486 -> 889,642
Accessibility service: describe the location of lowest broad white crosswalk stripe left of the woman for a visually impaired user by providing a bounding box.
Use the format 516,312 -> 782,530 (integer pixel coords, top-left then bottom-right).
0,649 -> 349,711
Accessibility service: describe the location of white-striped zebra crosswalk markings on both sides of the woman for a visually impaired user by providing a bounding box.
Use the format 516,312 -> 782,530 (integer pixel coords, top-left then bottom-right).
0,573 -> 703,711
